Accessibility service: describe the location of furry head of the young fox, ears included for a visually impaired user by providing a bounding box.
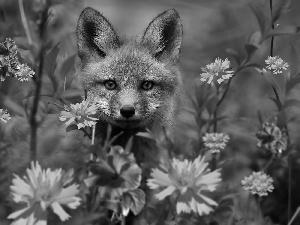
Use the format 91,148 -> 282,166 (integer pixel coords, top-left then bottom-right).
76,8 -> 182,129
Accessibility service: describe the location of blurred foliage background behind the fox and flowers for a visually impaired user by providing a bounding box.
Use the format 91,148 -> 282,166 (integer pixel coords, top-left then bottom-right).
0,0 -> 300,224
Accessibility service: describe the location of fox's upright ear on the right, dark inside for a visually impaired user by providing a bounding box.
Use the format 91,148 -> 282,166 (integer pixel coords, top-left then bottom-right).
142,9 -> 182,62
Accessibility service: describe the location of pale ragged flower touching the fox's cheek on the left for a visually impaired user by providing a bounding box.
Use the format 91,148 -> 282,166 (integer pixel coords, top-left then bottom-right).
59,100 -> 99,129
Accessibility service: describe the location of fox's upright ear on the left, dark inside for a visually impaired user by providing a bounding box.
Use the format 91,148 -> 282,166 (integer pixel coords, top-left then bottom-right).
76,7 -> 120,61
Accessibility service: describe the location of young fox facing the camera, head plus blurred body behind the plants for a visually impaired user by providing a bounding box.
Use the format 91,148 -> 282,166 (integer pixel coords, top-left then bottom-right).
0,7 -> 183,223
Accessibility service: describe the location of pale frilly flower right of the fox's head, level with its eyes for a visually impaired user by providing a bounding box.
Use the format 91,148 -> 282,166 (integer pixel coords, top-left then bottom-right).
200,58 -> 234,85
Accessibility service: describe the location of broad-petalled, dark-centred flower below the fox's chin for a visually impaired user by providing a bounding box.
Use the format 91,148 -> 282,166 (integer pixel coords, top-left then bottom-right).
84,146 -> 142,200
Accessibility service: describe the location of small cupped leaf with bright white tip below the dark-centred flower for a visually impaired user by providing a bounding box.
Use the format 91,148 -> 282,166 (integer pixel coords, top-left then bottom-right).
121,189 -> 146,216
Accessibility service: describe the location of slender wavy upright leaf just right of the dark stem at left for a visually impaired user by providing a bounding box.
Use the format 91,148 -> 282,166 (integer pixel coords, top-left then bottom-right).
43,45 -> 59,92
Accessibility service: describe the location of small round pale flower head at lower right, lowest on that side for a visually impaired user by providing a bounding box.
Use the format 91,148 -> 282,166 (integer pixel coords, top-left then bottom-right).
241,171 -> 274,196
